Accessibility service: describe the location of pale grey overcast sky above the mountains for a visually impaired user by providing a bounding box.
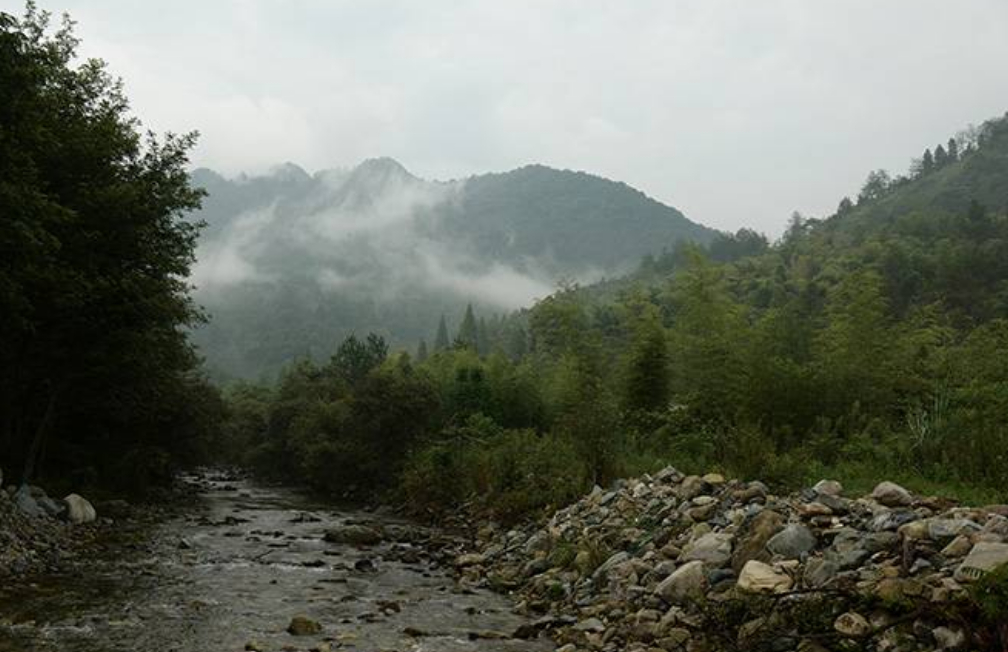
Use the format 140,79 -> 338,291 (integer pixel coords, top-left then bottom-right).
43,0 -> 1008,235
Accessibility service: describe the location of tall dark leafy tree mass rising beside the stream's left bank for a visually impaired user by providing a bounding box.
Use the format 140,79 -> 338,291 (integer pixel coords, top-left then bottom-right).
0,4 -> 216,491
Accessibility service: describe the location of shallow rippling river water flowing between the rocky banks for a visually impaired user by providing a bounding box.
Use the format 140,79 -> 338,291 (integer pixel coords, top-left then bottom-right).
0,477 -> 553,652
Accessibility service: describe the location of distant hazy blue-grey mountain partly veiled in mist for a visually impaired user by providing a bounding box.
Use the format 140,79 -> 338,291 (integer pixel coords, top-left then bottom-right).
192,158 -> 718,377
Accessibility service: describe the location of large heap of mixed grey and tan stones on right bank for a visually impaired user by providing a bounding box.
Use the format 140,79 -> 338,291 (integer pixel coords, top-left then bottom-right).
456,468 -> 1008,652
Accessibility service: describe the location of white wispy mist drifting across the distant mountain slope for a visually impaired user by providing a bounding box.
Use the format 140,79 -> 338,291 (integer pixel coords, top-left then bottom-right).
193,166 -> 556,309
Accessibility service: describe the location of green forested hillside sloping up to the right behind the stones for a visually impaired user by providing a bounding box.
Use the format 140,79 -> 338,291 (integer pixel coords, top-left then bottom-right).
224,113 -> 1008,516
